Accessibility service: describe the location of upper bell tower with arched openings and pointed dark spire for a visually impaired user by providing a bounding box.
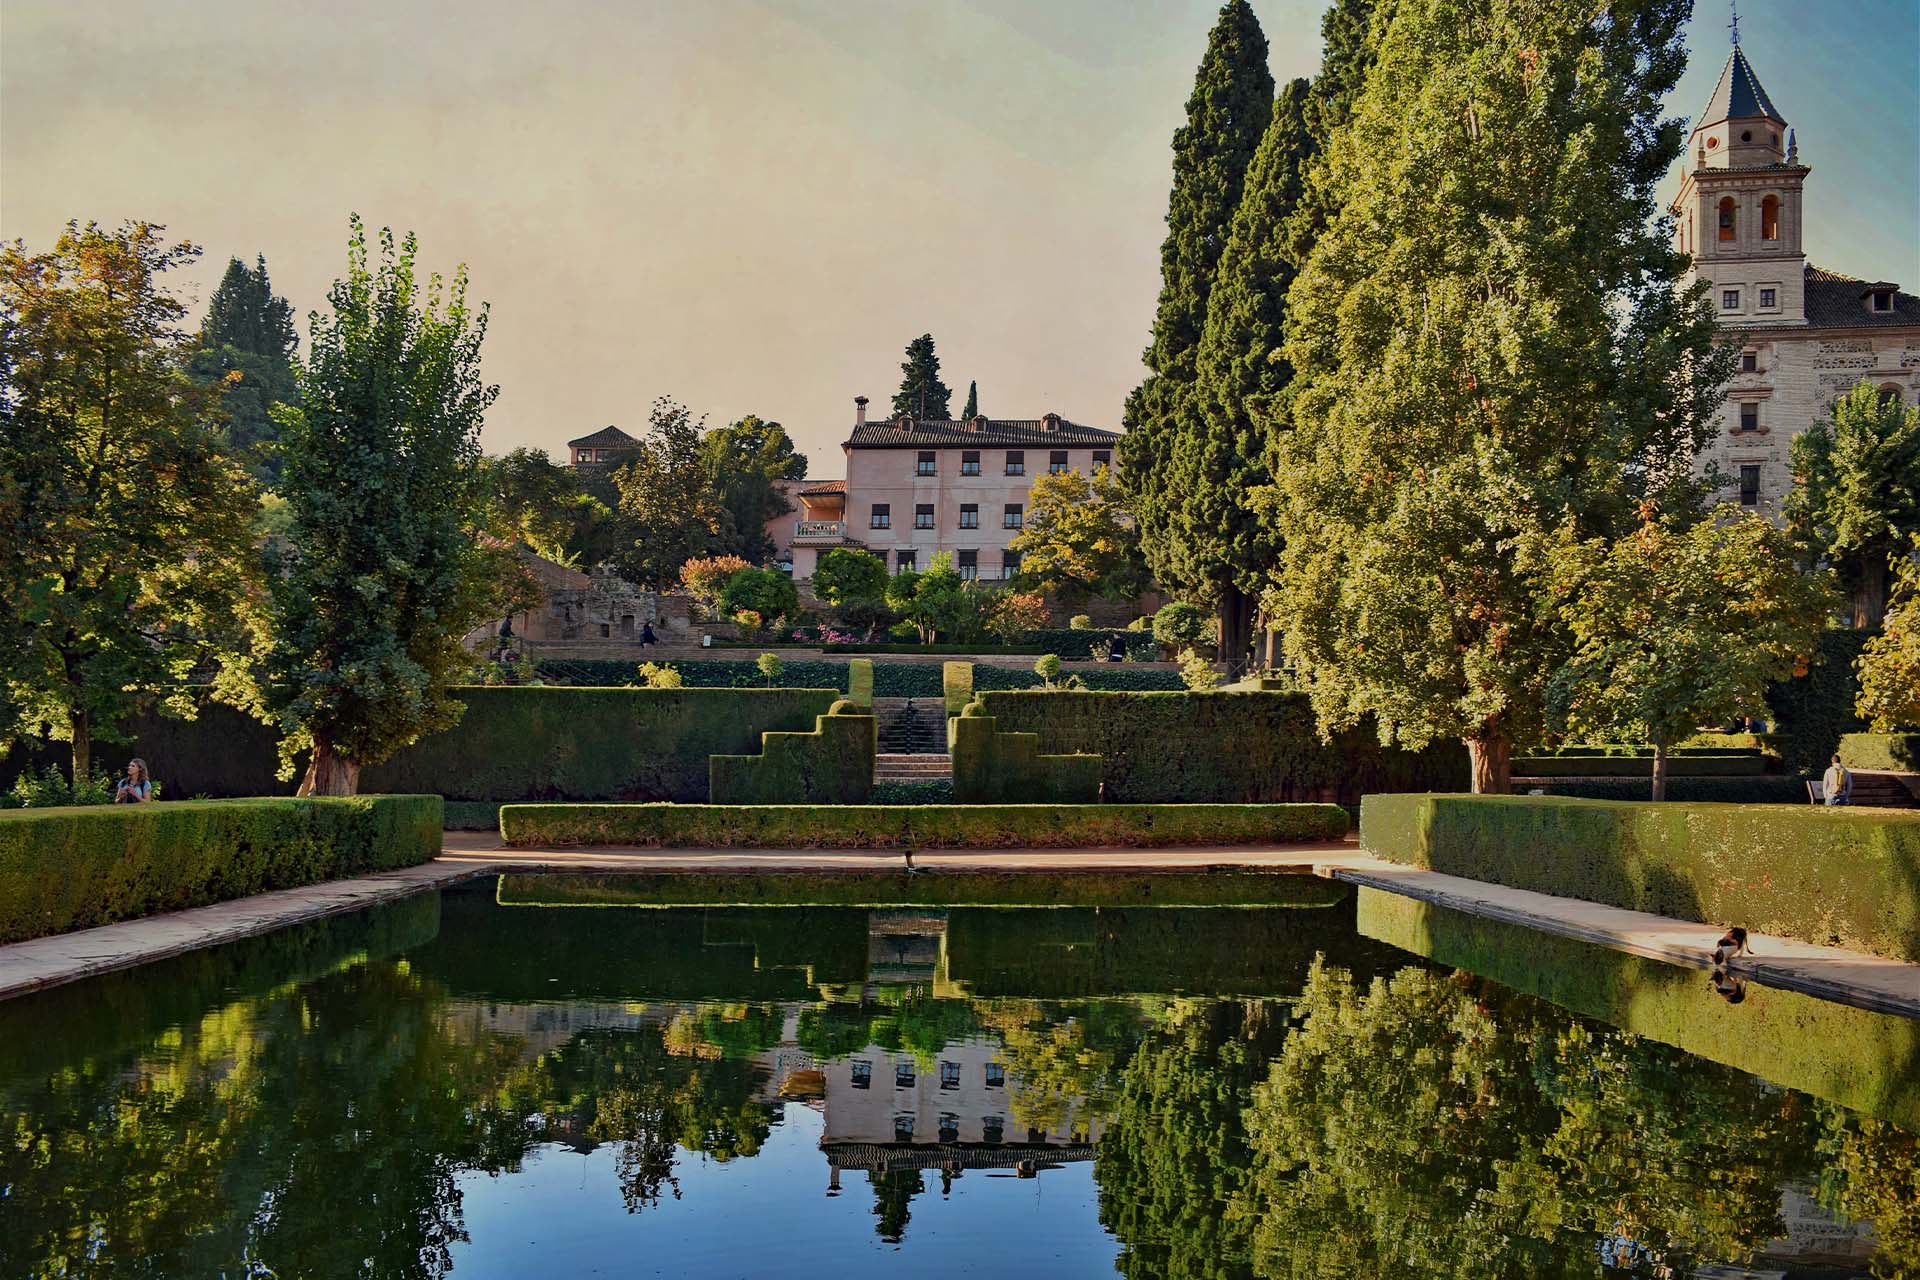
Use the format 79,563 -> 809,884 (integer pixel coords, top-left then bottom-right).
1670,25 -> 1809,328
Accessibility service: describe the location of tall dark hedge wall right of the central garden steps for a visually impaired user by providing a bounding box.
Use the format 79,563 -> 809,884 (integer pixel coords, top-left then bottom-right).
981,693 -> 1469,804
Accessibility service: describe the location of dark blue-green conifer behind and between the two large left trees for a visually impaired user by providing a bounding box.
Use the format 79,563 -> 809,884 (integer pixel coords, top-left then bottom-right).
186,255 -> 300,480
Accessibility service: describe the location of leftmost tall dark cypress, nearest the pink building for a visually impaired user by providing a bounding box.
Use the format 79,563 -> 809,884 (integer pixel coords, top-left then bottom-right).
1119,0 -> 1273,617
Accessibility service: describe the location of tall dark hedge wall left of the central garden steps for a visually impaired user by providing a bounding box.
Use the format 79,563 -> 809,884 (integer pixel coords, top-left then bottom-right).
361,687 -> 833,800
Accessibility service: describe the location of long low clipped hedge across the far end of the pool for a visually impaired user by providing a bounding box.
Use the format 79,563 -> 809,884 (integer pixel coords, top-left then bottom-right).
499,804 -> 1348,848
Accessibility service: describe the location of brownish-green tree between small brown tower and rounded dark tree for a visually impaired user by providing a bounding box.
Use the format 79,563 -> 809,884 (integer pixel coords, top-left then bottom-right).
612,395 -> 728,587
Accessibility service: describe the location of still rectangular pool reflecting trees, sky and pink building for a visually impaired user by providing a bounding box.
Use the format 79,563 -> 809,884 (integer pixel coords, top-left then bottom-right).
0,877 -> 1920,1280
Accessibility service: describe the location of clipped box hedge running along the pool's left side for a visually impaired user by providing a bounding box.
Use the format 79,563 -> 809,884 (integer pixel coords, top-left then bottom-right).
0,794 -> 442,942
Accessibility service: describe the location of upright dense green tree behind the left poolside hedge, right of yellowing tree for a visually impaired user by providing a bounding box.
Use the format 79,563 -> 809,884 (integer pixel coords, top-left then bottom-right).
261,224 -> 513,794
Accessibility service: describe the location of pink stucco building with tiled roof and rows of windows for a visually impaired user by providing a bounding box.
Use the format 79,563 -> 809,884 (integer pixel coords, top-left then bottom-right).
768,395 -> 1119,581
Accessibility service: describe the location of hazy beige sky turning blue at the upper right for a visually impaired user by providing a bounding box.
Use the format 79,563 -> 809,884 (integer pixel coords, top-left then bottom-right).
0,0 -> 1920,478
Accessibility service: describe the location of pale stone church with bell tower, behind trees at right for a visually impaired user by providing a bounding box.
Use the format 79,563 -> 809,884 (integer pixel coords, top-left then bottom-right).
1670,46 -> 1920,520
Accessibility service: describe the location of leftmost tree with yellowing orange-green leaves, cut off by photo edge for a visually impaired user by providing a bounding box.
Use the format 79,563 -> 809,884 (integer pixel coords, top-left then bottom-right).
0,223 -> 259,783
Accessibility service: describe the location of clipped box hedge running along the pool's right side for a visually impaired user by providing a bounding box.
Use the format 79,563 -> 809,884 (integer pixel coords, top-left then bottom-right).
1359,794 -> 1920,961
